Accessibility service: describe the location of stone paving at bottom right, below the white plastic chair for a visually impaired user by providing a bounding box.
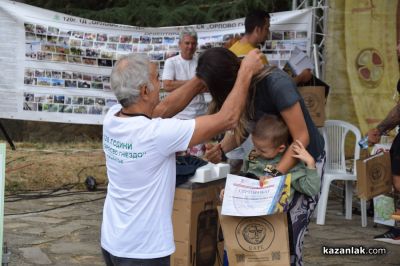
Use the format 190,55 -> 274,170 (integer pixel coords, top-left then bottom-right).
304,199 -> 400,266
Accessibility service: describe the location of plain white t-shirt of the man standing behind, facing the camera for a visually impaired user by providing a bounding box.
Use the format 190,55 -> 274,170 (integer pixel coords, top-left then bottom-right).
162,54 -> 207,119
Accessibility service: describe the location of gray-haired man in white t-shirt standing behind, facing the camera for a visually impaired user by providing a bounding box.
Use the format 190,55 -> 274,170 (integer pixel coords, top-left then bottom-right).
162,27 -> 207,119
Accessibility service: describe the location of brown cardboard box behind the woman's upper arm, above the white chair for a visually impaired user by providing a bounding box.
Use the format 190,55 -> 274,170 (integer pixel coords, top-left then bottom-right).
298,86 -> 326,127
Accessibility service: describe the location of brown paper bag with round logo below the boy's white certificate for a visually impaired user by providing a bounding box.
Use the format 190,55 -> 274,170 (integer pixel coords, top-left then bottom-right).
218,207 -> 290,266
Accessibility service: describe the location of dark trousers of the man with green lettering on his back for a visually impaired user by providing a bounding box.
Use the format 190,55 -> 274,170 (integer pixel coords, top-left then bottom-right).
101,248 -> 171,266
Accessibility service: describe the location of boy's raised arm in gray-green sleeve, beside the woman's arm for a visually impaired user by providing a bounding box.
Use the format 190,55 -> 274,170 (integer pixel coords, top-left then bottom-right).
291,140 -> 321,197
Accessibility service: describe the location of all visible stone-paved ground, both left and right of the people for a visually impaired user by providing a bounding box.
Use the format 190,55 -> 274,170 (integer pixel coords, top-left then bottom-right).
4,188 -> 400,266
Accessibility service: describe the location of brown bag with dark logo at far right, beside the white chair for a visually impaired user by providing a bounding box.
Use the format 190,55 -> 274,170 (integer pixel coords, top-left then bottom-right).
356,152 -> 392,200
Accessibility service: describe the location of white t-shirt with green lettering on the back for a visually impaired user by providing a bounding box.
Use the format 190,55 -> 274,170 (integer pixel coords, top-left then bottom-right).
101,104 -> 195,259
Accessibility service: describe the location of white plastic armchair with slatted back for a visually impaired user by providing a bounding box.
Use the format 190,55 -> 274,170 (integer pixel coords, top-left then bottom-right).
317,120 -> 367,227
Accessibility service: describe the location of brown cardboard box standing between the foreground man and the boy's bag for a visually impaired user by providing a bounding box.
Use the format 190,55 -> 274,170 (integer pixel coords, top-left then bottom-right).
171,179 -> 225,266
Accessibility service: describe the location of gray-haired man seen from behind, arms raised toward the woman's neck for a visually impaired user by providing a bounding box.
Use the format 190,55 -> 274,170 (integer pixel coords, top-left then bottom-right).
101,51 -> 262,265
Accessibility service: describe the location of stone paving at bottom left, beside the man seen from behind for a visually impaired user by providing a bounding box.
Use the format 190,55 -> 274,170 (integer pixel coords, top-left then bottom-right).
4,191 -> 105,266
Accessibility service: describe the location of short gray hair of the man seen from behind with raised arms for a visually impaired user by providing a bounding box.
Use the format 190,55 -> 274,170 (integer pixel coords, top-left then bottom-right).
111,54 -> 153,107
